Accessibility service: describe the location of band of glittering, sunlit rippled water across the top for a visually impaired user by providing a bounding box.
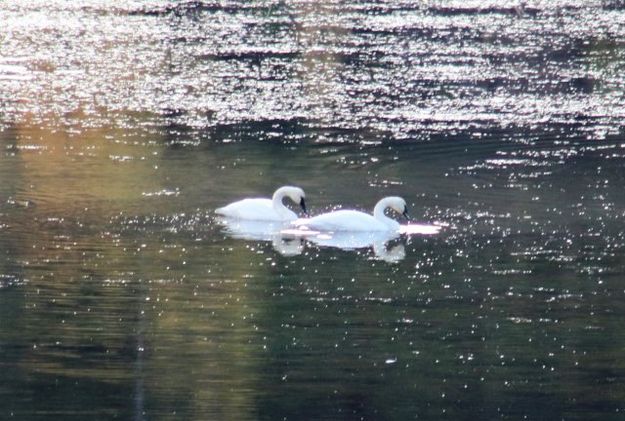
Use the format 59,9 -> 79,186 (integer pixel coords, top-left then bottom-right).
0,0 -> 625,140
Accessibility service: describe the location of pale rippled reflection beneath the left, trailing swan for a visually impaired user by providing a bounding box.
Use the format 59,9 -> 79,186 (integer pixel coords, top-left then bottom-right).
215,217 -> 304,256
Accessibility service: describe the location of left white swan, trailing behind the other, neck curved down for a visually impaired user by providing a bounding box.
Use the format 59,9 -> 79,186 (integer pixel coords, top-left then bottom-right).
215,186 -> 306,221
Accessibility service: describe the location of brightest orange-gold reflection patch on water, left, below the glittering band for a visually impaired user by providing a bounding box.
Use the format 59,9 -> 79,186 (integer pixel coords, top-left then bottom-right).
5,115 -> 163,212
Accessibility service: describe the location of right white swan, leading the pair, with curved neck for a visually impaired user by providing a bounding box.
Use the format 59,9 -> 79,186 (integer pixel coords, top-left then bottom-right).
294,196 -> 408,232
